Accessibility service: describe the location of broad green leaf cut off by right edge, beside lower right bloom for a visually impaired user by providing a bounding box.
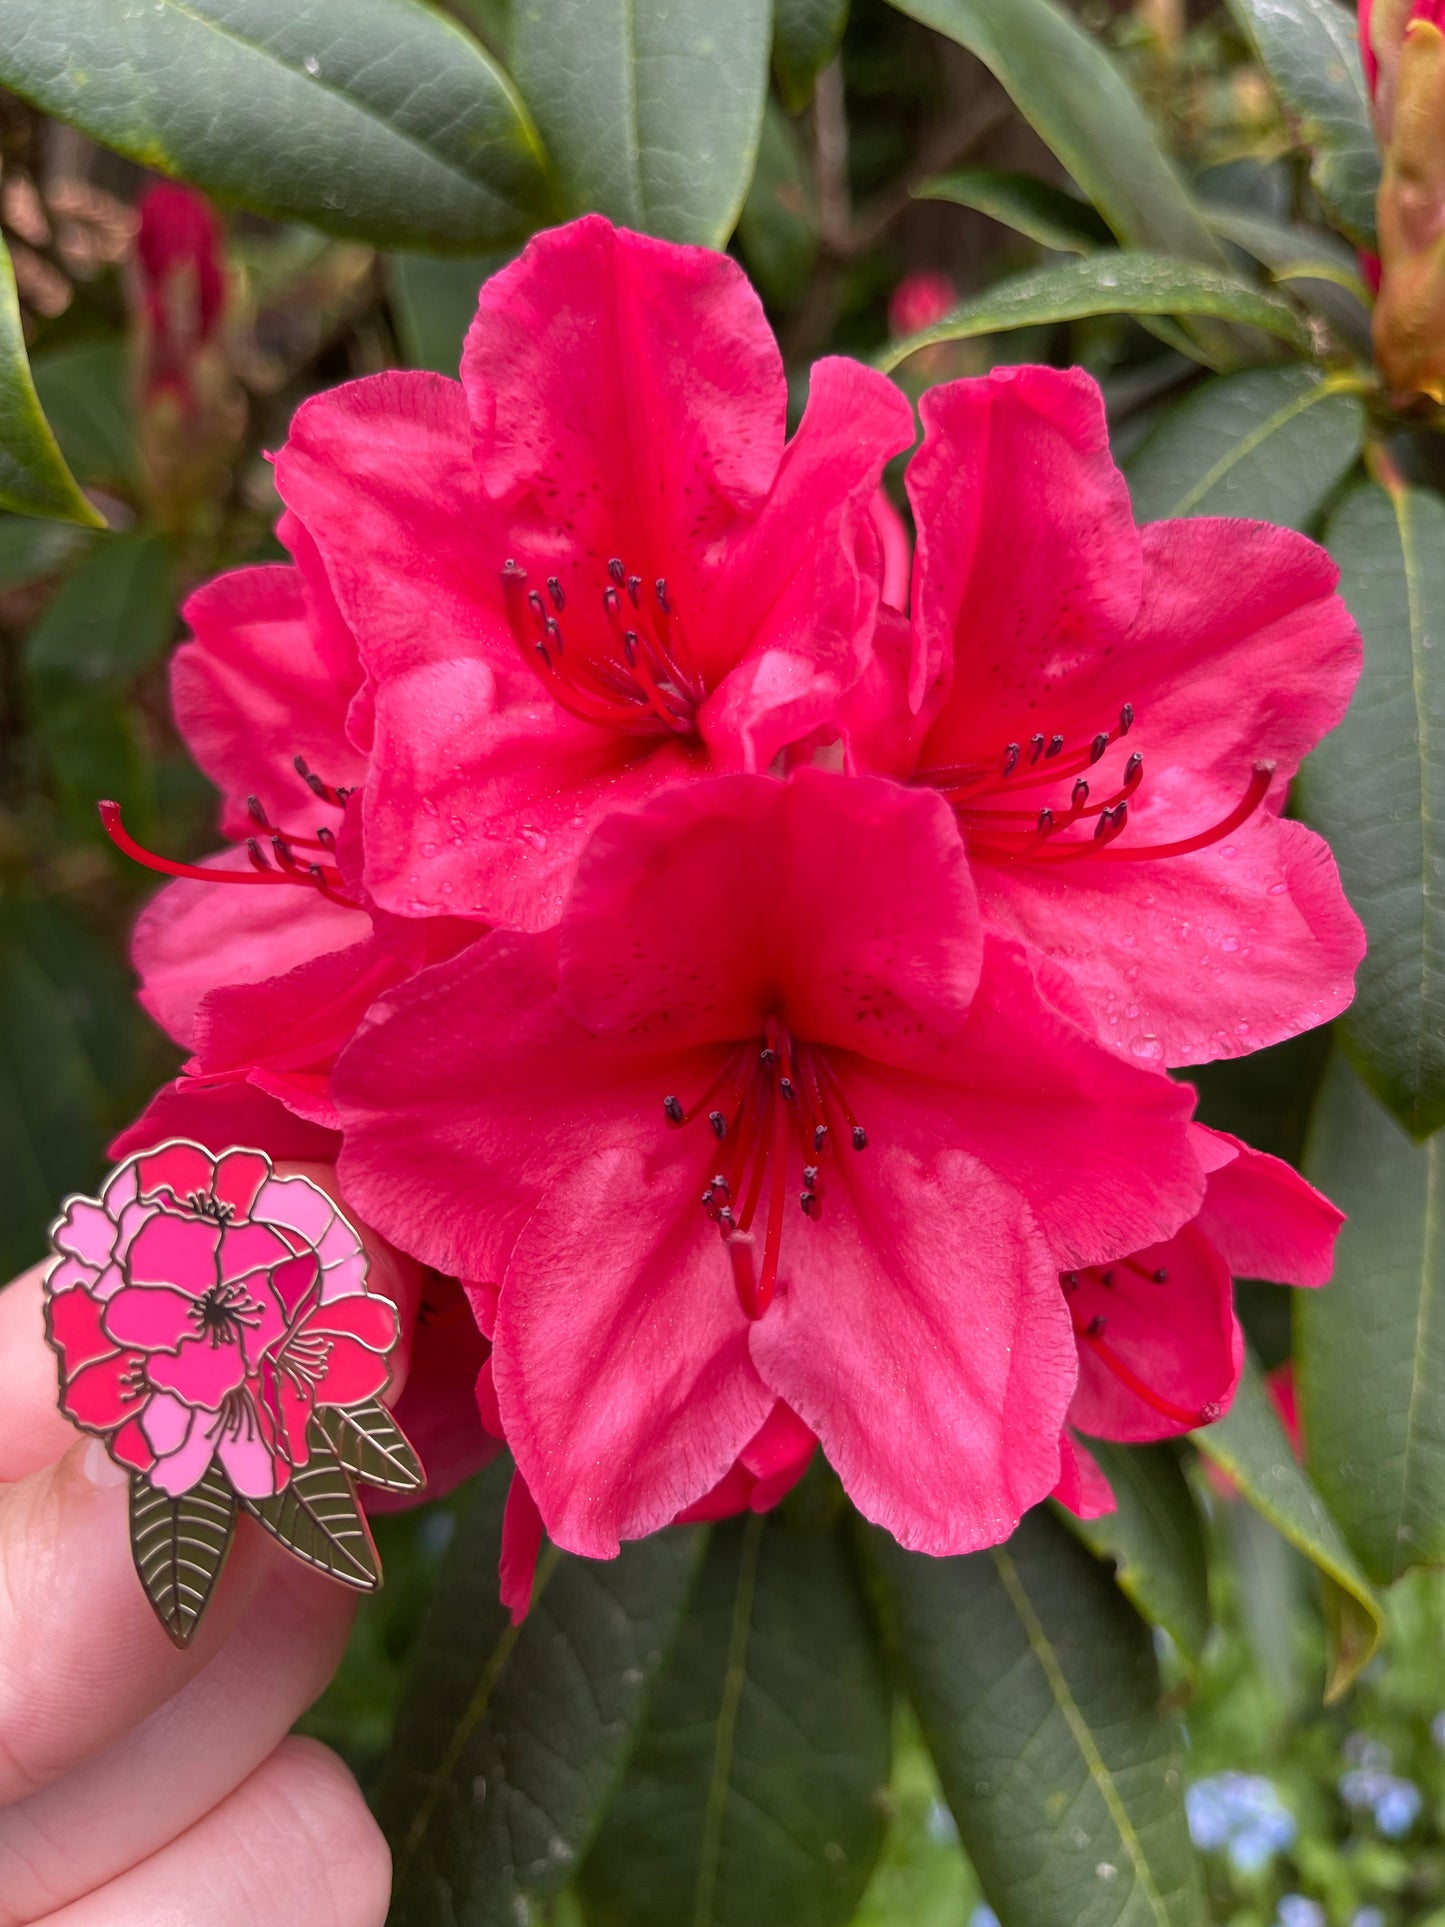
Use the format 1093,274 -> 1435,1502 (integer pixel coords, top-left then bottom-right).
1295,1054 -> 1445,1586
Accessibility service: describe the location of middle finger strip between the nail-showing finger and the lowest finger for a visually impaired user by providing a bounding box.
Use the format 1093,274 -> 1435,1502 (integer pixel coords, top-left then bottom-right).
0,1559 -> 355,1927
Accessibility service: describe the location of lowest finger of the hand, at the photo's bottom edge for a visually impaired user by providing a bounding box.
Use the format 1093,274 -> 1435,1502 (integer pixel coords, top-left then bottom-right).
33,1740 -> 391,1927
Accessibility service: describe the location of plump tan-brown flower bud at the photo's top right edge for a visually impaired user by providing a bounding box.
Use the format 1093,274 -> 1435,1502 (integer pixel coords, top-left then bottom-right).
1374,16 -> 1445,401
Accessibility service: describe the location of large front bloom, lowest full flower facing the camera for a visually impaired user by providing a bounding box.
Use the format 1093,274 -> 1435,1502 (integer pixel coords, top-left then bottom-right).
333,769 -> 1204,1555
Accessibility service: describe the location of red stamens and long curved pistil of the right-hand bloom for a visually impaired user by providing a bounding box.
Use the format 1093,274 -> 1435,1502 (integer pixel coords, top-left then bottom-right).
917,703 -> 1274,865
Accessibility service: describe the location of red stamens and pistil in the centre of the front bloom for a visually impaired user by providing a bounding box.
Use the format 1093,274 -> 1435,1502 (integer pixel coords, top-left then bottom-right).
663,1017 -> 869,1318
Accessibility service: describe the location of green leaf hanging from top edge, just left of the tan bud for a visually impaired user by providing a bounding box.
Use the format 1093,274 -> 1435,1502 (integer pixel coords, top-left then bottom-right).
1229,0 -> 1379,249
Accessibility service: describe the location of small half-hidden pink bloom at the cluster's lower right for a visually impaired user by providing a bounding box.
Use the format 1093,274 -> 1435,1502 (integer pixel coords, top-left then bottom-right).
1060,1123 -> 1345,1517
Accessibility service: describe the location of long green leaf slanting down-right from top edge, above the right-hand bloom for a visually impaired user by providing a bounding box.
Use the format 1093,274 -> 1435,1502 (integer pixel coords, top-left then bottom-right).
894,0 -> 1223,268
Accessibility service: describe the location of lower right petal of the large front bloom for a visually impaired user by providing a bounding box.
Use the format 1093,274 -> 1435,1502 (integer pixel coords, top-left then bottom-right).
751,1147 -> 1077,1553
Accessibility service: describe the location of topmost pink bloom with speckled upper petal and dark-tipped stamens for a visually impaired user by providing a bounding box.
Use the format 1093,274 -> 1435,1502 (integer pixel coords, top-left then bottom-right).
276,216 -> 913,929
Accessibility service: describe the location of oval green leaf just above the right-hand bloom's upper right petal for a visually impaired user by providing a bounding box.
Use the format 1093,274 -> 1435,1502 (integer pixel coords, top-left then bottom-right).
1127,368 -> 1364,528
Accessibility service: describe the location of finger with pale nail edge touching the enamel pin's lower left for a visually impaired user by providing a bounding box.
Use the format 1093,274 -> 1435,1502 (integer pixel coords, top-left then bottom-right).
0,1439 -> 285,1808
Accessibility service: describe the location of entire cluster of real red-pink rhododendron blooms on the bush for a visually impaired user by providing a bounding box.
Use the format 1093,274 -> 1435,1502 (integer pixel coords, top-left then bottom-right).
108,218 -> 1362,1605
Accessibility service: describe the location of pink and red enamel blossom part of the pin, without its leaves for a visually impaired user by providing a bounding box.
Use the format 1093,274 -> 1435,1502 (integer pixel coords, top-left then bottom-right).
46,1141 -> 397,1499
